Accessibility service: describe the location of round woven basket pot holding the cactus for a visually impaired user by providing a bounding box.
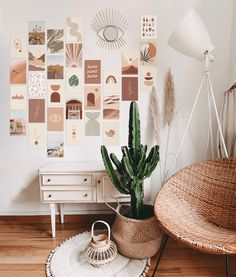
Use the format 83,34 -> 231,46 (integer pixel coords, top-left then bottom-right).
112,205 -> 163,259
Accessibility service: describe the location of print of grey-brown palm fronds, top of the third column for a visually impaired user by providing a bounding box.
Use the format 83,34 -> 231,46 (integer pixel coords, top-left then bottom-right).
47,29 -> 64,54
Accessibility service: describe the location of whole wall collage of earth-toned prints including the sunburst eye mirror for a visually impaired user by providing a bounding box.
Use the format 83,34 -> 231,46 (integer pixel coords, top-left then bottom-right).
10,9 -> 157,157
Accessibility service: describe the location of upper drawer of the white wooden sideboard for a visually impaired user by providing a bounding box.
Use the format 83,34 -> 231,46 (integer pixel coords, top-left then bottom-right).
42,173 -> 94,186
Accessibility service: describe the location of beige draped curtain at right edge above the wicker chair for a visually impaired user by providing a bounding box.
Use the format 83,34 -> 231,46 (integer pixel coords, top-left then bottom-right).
216,83 -> 236,157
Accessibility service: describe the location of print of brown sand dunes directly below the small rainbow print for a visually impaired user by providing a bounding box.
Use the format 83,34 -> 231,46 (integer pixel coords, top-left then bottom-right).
103,95 -> 120,119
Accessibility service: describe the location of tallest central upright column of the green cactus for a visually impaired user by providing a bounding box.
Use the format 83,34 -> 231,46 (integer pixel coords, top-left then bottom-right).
128,101 -> 141,160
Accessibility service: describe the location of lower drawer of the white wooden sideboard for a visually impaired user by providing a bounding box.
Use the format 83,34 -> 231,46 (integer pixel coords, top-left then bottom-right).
42,189 -> 96,202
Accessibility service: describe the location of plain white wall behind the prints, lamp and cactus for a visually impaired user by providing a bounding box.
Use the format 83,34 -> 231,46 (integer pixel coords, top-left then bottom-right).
0,0 -> 233,214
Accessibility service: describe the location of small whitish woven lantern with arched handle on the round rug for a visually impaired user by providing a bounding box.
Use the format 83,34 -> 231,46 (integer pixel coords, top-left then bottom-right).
85,220 -> 117,267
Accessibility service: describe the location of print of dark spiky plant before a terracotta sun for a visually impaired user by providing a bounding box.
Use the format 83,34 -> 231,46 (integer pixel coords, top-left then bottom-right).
140,41 -> 157,65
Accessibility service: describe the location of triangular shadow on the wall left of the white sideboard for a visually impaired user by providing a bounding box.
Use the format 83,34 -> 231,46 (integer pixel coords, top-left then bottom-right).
12,176 -> 40,205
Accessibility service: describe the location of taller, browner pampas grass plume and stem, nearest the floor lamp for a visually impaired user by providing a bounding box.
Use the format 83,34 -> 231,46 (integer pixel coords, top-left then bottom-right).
164,69 -> 175,181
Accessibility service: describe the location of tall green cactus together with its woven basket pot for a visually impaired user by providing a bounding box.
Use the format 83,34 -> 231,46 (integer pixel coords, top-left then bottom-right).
101,102 -> 162,259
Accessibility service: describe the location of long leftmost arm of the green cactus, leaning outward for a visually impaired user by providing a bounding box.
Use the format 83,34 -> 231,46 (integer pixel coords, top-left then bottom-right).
101,145 -> 127,194
